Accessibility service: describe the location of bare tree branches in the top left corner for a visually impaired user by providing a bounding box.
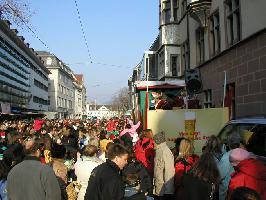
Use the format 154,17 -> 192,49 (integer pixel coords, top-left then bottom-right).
0,0 -> 33,24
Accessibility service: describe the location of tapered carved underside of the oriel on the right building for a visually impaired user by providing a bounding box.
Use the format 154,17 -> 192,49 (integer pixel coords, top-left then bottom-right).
189,0 -> 212,28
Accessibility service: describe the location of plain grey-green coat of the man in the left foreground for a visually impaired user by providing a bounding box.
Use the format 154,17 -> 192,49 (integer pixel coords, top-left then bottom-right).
7,157 -> 61,200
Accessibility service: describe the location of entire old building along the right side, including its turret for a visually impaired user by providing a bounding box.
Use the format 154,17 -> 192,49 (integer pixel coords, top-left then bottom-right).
128,0 -> 266,118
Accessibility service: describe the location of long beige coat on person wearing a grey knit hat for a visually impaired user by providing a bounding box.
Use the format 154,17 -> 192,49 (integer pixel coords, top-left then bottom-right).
154,142 -> 175,196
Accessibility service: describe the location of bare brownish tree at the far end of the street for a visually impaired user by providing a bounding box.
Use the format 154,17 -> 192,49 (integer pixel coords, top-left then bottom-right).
111,87 -> 129,112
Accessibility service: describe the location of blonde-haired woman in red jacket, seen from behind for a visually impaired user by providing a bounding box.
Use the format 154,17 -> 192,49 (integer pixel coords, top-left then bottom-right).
175,138 -> 199,196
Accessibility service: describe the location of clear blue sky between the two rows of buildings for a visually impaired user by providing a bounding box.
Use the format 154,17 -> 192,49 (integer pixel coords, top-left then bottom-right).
18,0 -> 159,103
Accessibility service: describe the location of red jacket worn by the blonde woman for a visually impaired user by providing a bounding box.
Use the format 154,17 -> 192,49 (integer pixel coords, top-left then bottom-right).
175,155 -> 199,189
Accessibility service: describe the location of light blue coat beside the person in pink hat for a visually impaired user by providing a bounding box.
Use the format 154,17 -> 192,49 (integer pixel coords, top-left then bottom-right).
214,151 -> 234,200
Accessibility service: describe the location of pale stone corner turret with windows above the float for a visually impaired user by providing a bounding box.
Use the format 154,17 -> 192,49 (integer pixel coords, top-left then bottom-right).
157,0 -> 181,80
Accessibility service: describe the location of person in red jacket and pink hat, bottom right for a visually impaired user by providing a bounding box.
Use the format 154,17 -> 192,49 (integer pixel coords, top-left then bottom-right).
228,148 -> 266,199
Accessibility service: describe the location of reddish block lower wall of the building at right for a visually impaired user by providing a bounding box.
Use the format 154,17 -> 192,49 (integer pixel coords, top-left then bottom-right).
200,31 -> 266,117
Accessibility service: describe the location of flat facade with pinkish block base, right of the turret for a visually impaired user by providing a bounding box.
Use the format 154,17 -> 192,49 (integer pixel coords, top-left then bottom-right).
178,0 -> 266,118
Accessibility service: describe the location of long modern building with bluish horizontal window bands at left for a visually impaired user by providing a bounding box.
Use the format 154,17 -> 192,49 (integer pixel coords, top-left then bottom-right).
0,20 -> 50,113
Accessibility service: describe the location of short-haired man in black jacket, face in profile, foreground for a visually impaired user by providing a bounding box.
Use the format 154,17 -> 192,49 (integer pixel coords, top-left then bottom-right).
84,144 -> 128,200
